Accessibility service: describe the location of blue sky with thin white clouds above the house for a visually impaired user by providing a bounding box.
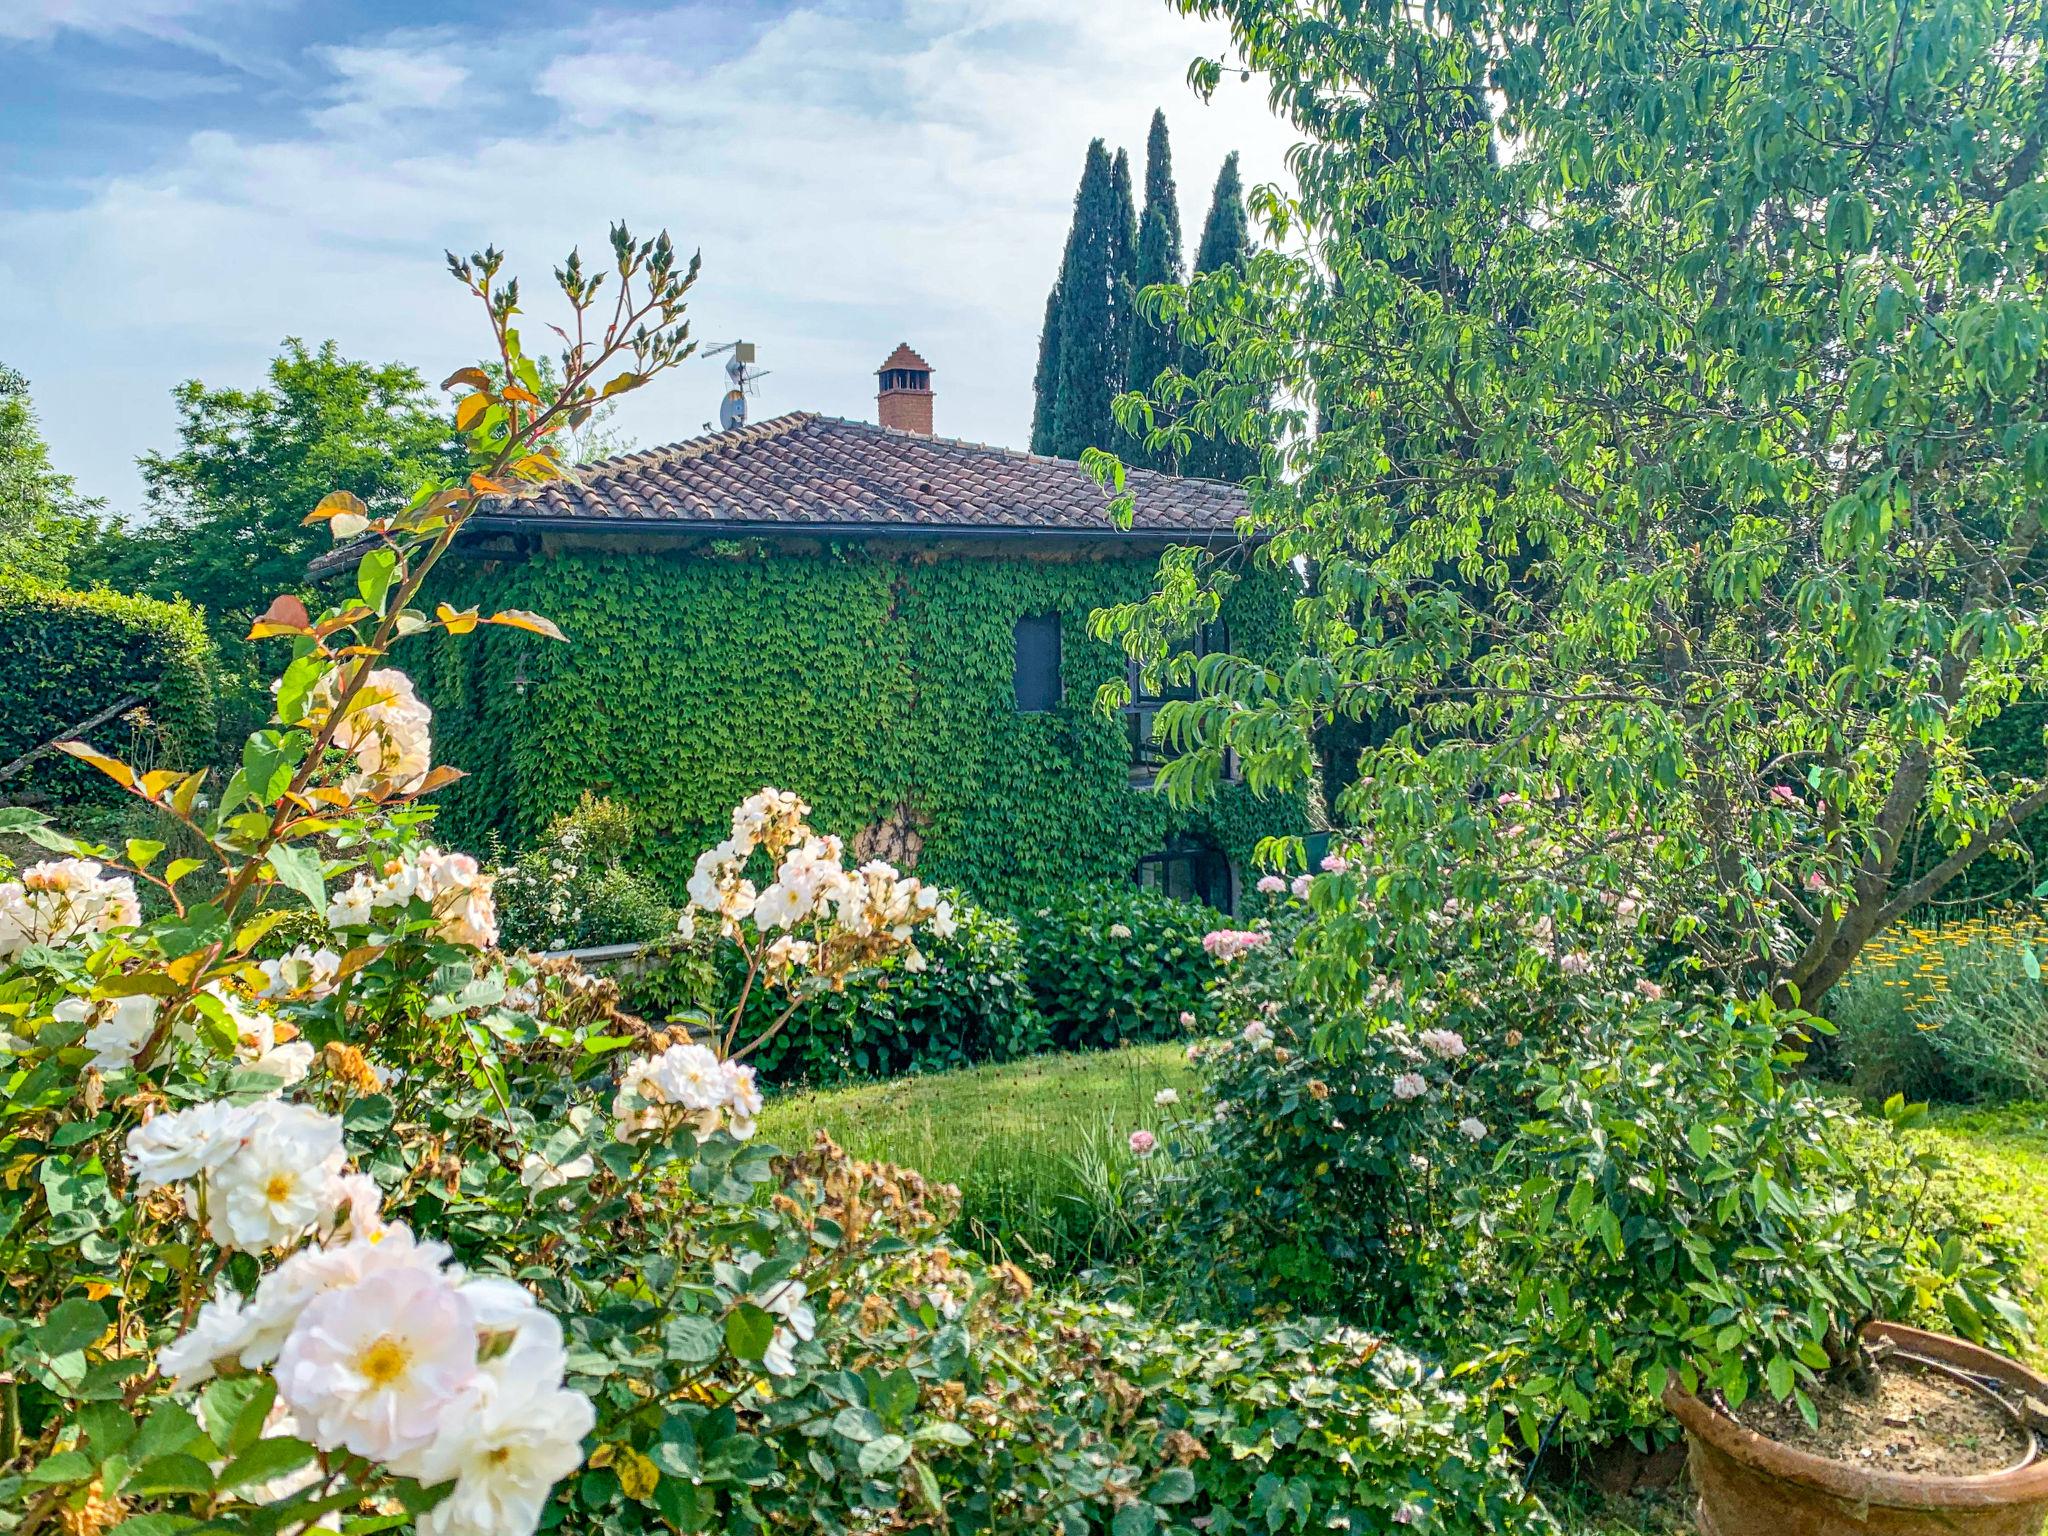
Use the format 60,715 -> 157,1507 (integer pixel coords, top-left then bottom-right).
0,0 -> 1290,516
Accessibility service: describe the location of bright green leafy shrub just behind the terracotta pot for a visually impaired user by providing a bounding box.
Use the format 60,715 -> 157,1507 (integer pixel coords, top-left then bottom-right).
1458,1004 -> 2028,1446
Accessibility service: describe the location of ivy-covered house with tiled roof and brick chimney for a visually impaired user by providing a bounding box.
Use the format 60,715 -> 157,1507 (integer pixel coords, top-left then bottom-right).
422,346 -> 1300,909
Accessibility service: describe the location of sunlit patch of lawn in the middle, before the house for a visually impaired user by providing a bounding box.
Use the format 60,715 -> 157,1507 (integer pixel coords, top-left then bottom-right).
762,1044 -> 1194,1276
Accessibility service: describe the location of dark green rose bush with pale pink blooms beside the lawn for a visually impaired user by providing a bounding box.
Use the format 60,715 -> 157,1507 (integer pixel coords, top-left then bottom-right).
1151,899 -> 1647,1337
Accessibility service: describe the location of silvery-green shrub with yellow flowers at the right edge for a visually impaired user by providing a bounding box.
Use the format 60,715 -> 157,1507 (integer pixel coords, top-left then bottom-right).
1827,907 -> 2048,1104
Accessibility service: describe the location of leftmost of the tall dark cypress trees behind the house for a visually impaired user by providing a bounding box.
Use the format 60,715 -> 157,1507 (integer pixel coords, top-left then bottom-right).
1032,139 -> 1128,459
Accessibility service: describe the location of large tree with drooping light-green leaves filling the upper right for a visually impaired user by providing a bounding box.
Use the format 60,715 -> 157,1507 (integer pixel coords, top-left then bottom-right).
1102,0 -> 2048,1004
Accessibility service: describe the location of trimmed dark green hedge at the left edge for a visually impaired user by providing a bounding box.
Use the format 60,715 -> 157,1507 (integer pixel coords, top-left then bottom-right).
0,571 -> 215,801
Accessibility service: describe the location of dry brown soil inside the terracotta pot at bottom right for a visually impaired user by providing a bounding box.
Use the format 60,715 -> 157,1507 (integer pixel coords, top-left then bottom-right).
1733,1356 -> 2034,1477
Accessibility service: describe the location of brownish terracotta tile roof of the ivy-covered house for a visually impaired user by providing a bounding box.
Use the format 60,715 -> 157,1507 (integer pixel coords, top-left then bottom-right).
479,411 -> 1245,535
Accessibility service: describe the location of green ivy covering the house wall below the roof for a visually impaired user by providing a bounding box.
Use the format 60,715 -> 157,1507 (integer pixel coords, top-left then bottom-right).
424,541 -> 1303,907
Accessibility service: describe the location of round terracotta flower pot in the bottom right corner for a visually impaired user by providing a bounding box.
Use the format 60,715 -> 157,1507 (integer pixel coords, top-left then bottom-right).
1665,1323 -> 2048,1536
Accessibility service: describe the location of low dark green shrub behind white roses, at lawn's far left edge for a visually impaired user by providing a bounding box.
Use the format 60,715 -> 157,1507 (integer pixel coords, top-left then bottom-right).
623,905 -> 1047,1085
